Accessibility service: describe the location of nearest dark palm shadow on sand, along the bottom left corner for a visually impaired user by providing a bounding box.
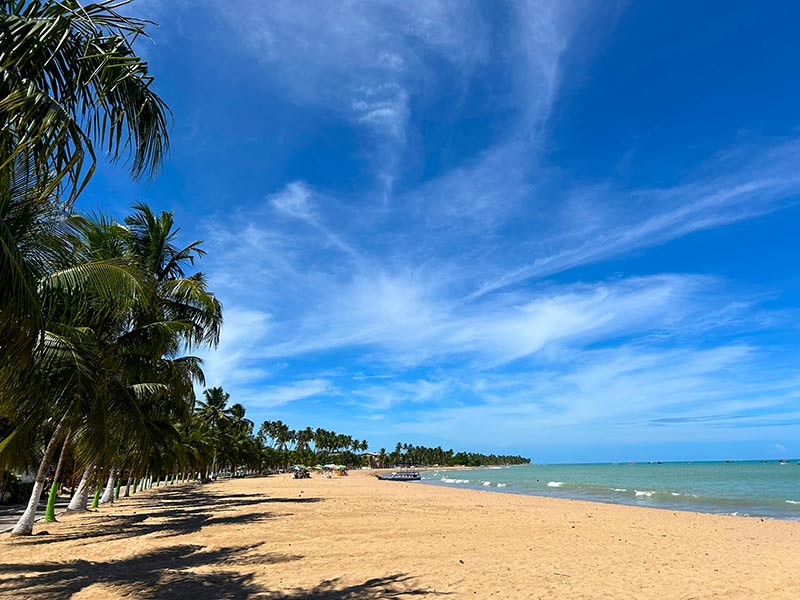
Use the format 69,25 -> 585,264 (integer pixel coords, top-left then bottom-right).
0,544 -> 302,600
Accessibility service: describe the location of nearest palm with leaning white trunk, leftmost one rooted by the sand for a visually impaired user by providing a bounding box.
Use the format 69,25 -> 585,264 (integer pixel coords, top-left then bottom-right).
0,247 -> 148,534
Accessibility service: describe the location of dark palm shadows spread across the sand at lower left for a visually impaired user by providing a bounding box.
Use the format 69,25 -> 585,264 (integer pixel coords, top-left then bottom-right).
0,486 -> 447,600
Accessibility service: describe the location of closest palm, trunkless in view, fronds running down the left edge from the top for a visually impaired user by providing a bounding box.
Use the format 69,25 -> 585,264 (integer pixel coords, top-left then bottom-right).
0,0 -> 169,380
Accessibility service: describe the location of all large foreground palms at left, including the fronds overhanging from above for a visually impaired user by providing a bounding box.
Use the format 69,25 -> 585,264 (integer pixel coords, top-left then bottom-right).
0,0 -> 205,534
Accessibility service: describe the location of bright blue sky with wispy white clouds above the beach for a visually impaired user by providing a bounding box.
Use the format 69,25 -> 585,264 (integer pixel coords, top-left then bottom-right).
79,0 -> 800,462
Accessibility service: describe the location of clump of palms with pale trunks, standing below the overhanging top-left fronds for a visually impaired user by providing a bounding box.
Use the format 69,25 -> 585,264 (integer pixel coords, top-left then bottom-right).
0,204 -> 222,534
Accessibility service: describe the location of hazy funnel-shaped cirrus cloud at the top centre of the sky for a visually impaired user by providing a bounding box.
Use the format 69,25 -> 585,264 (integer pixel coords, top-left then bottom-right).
206,0 -> 500,199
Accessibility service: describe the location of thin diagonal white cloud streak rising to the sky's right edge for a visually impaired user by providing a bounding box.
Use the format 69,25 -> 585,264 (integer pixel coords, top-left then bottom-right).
474,141 -> 800,296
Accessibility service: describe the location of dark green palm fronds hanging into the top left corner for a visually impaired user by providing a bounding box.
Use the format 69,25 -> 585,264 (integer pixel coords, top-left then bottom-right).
0,0 -> 169,198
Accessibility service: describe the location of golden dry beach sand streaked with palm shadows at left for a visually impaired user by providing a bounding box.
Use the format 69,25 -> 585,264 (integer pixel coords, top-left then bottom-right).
0,473 -> 800,600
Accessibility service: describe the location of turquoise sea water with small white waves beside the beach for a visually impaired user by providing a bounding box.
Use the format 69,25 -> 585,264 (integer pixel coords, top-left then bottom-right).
422,459 -> 800,521
